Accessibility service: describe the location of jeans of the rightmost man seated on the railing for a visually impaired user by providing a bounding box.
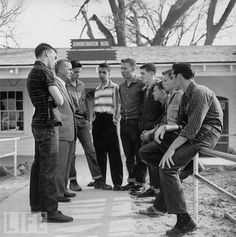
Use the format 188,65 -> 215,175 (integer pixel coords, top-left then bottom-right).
154,128 -> 221,214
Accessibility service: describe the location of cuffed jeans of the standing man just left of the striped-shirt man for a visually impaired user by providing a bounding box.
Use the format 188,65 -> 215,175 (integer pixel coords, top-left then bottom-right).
69,126 -> 102,180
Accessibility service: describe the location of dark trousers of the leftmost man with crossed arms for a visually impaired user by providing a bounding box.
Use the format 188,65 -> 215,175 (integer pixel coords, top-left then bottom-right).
30,127 -> 59,212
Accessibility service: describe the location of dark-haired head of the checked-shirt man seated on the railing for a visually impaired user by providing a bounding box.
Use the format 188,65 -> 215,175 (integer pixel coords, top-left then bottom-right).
172,62 -> 194,89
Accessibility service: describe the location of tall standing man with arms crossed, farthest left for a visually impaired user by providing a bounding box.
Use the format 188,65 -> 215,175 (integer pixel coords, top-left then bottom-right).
27,43 -> 73,222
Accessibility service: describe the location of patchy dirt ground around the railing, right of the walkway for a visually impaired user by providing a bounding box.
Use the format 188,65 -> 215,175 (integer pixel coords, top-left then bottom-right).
131,167 -> 236,237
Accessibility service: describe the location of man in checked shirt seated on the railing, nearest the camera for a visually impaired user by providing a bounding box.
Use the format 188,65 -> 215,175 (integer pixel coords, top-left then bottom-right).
139,63 -> 223,236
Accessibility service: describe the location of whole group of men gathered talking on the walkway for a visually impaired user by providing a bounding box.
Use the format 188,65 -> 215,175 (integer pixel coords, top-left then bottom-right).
27,43 -> 223,236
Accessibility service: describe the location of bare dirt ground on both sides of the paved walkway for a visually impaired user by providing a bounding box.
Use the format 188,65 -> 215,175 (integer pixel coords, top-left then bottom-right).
0,166 -> 236,237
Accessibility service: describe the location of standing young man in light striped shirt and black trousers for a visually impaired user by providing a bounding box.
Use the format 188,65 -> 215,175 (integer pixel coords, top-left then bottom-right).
92,63 -> 123,191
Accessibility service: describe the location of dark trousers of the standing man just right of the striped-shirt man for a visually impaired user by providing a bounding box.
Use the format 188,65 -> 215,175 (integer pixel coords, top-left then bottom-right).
120,119 -> 147,184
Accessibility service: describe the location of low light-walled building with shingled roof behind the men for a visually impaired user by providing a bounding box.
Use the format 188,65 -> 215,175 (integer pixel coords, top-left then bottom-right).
0,46 -> 236,155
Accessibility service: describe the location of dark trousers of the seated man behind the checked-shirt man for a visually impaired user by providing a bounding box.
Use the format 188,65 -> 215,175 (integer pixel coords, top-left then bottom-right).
139,132 -> 178,188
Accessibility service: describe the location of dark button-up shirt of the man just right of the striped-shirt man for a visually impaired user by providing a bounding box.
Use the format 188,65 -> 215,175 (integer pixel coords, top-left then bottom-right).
119,78 -> 145,120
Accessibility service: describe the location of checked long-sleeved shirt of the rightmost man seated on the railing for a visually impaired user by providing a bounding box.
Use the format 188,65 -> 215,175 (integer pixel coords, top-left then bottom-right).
180,81 -> 223,140
